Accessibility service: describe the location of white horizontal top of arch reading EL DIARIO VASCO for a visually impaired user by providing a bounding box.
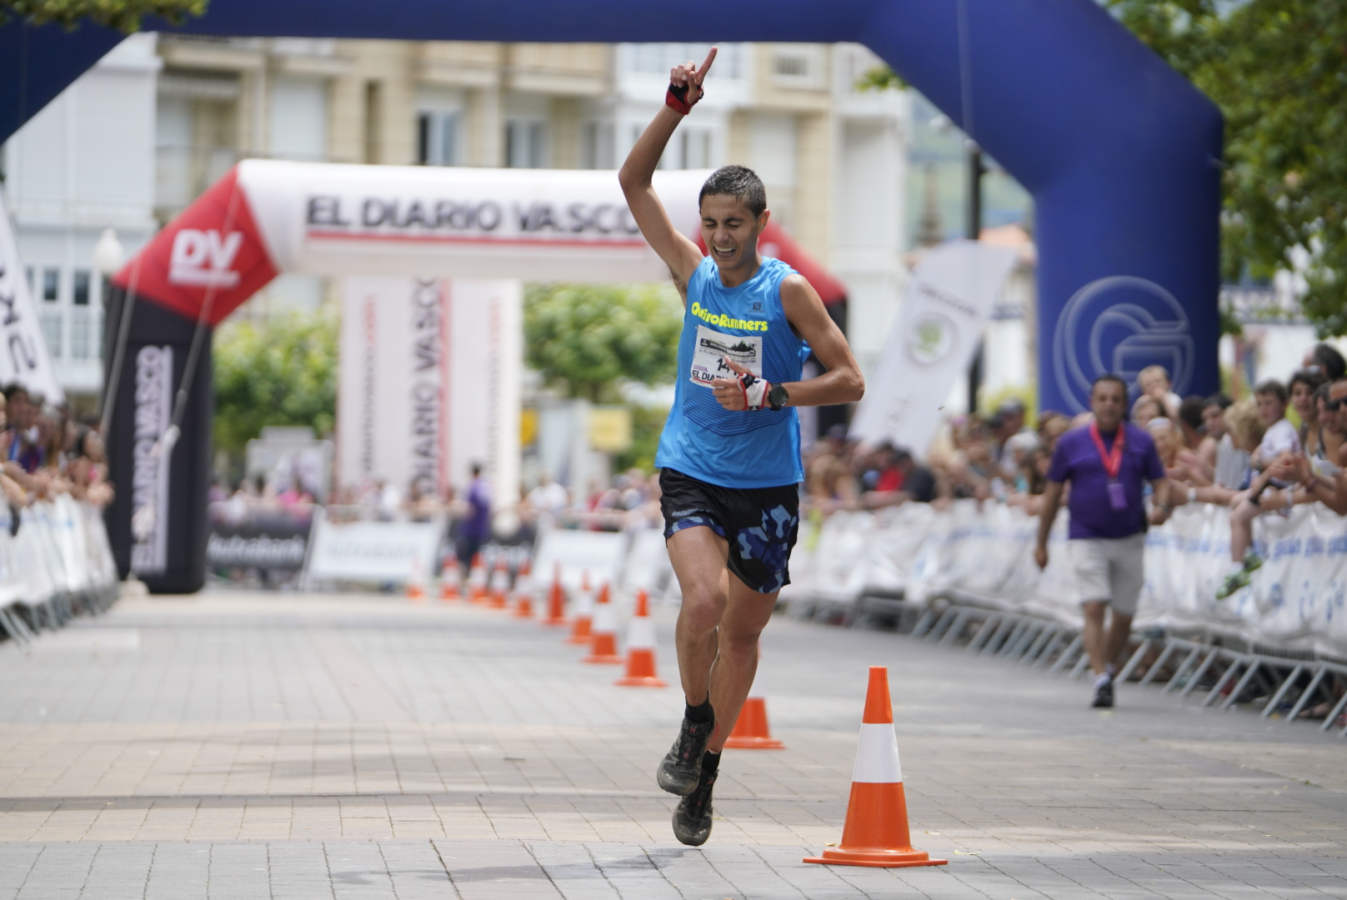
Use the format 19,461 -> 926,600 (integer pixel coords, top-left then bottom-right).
238,159 -> 709,282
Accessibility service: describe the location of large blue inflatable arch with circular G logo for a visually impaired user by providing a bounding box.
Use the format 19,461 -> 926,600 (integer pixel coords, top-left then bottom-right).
0,0 -> 1222,590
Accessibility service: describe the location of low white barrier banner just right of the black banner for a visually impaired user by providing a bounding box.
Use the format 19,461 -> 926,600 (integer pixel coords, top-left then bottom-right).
304,512 -> 445,585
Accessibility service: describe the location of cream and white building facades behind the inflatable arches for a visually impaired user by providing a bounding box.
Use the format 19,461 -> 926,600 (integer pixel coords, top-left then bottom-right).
0,35 -> 909,395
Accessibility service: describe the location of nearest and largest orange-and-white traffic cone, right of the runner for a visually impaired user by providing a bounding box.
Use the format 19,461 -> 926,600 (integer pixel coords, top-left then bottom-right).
804,666 -> 948,868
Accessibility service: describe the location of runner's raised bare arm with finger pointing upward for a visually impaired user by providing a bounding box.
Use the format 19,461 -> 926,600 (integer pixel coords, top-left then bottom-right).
617,47 -> 715,293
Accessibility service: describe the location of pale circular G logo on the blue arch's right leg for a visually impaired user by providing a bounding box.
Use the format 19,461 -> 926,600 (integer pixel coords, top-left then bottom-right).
1052,275 -> 1193,412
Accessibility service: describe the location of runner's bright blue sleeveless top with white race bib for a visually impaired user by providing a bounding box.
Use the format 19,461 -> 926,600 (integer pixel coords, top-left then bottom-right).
655,257 -> 808,488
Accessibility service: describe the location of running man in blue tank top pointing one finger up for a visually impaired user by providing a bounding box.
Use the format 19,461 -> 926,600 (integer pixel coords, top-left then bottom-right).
618,47 -> 865,846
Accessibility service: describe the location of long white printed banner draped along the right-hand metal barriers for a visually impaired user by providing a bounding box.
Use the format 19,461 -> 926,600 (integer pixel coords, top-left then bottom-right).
787,500 -> 1347,656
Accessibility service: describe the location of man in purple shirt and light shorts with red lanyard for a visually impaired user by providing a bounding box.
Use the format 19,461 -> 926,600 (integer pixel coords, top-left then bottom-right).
1033,375 -> 1173,707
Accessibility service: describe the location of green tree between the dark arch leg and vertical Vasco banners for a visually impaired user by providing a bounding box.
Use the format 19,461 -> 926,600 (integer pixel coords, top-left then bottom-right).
214,314 -> 337,455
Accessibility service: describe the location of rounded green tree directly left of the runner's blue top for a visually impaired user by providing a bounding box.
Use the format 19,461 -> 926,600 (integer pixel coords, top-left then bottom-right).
524,284 -> 683,403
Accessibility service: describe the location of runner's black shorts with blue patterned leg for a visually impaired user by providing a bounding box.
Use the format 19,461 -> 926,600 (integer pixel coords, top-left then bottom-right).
660,469 -> 800,594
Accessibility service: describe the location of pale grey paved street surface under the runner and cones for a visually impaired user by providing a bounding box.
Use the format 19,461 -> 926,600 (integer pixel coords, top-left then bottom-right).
0,593 -> 1347,900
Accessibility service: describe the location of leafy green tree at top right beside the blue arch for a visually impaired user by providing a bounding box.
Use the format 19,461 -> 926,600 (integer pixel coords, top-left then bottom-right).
1107,0 -> 1347,337
